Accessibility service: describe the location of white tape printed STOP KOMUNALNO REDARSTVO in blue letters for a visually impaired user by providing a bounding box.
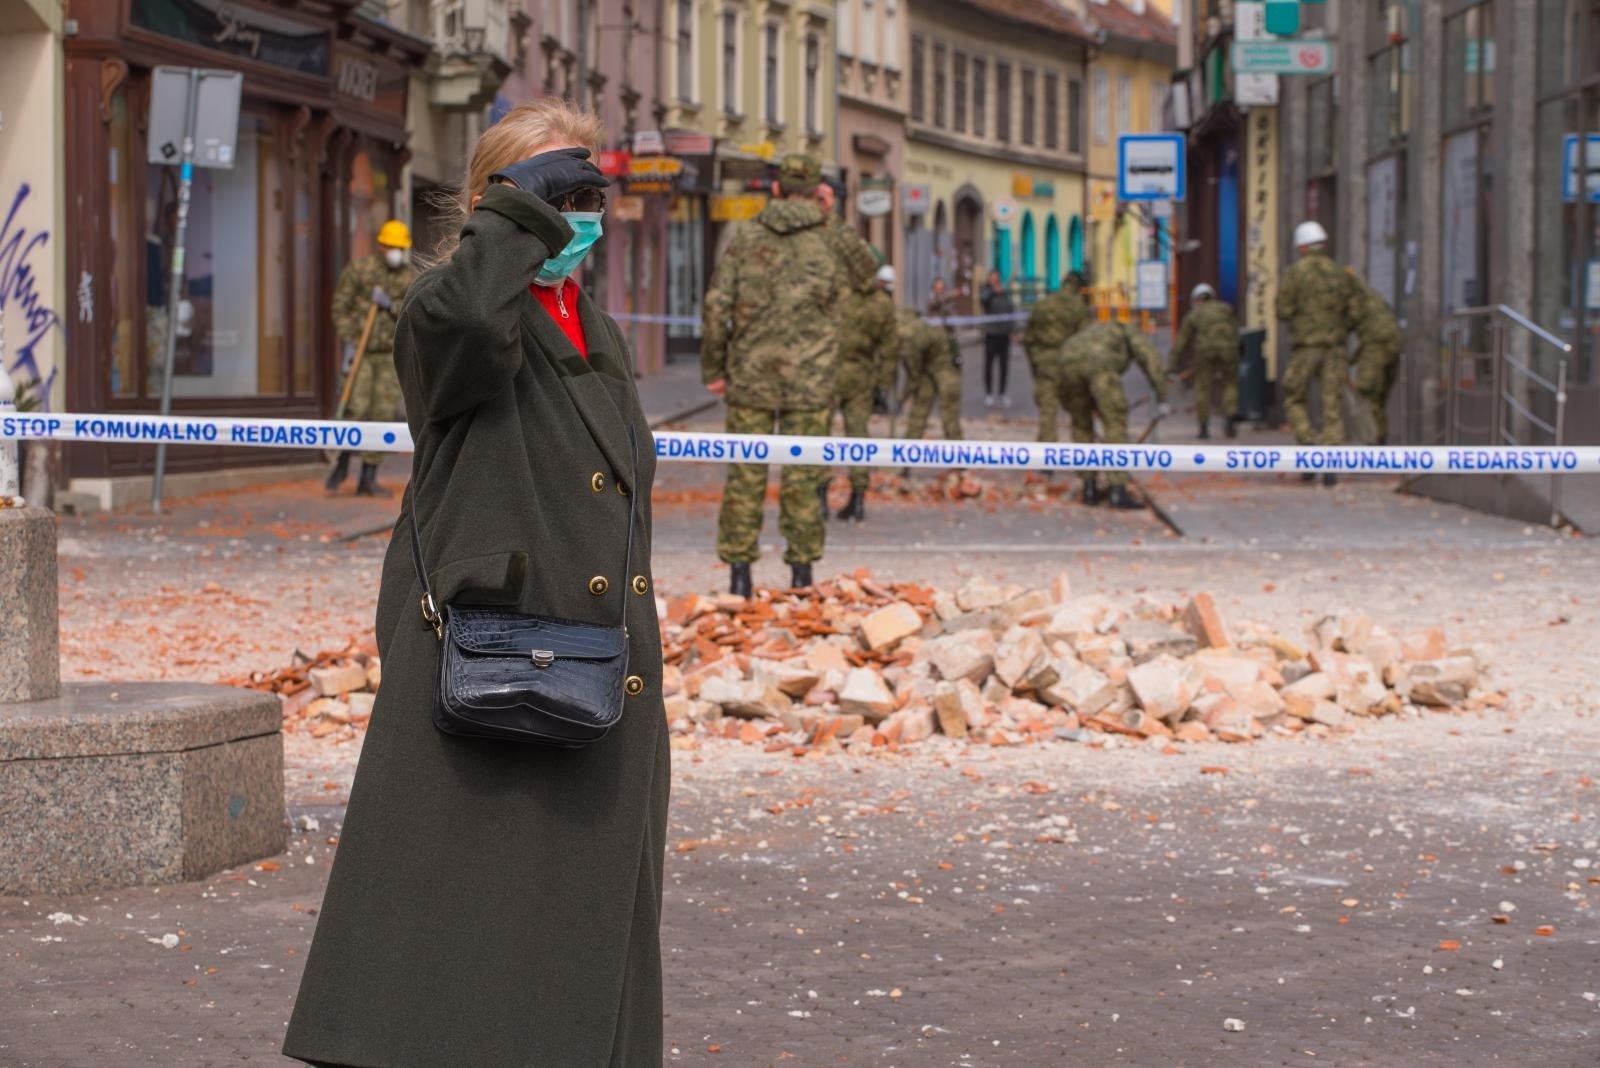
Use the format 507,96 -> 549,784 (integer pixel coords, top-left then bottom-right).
0,412 -> 1600,475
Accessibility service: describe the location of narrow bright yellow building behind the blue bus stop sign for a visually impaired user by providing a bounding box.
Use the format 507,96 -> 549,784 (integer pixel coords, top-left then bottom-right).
1086,0 -> 1178,294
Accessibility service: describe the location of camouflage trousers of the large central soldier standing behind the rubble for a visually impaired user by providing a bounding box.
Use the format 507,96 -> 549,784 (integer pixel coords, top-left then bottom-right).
717,398 -> 832,564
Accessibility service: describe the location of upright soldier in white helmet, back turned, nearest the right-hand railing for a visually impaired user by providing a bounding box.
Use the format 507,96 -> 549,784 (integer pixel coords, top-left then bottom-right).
1277,222 -> 1357,486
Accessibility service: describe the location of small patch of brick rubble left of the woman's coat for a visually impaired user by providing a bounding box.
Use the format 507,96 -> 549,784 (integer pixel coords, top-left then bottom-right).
226,643 -> 382,742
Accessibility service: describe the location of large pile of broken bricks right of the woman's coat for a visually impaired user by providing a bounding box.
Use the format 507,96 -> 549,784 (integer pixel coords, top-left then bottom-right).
662,572 -> 1504,755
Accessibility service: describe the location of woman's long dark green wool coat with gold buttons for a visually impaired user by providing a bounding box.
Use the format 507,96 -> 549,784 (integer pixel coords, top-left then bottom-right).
283,185 -> 670,1068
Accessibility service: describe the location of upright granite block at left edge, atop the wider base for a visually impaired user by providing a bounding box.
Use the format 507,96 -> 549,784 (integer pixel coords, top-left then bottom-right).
0,508 -> 61,702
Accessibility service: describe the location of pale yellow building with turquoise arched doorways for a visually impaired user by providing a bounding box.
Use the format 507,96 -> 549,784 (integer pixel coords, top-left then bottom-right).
885,0 -> 1093,308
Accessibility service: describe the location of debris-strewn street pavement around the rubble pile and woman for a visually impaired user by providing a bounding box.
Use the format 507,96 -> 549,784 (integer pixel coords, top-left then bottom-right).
0,398 -> 1600,1068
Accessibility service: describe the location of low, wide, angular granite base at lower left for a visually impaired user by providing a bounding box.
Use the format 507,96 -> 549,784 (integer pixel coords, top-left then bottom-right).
0,684 -> 286,894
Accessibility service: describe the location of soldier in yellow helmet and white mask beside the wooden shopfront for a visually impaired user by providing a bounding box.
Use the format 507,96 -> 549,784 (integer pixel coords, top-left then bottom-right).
328,219 -> 416,497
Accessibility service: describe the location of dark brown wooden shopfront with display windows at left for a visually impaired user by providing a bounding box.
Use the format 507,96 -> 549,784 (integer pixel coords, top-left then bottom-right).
62,0 -> 427,480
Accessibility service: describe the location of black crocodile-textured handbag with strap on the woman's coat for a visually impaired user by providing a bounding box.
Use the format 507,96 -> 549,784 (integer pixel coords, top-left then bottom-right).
411,432 -> 642,748
